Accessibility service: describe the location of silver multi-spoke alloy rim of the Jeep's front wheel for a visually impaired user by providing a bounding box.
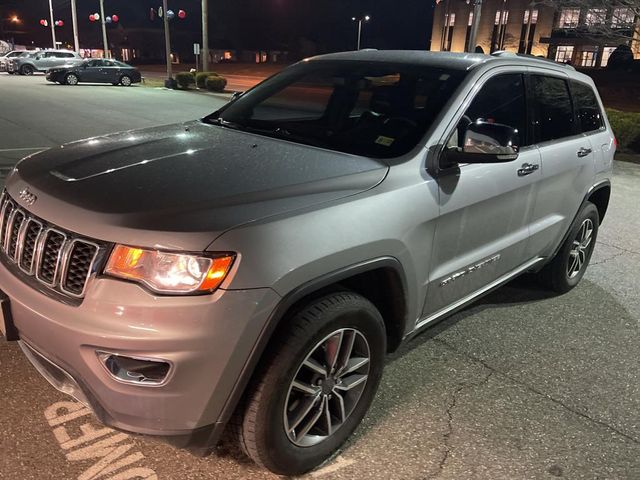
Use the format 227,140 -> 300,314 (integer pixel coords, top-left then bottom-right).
284,328 -> 371,447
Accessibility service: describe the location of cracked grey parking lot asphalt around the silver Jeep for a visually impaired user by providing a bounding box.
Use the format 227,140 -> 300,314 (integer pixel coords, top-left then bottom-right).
0,74 -> 640,480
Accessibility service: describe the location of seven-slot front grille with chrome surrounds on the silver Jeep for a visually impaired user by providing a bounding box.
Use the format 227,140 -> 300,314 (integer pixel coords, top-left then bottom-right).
0,192 -> 100,298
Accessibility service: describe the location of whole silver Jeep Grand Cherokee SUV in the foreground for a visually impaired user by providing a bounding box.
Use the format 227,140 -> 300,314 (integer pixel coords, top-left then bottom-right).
0,51 -> 615,474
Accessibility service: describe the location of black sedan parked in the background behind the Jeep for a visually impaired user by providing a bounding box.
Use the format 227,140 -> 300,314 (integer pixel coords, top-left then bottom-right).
47,58 -> 142,87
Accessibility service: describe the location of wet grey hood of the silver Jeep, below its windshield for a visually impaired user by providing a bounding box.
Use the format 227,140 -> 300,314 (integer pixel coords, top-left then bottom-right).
7,122 -> 388,251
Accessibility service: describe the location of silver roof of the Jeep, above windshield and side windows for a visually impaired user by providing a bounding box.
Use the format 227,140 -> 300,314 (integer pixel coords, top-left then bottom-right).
308,50 -> 574,72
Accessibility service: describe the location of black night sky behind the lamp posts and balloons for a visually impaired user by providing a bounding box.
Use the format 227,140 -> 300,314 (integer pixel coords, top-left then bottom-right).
0,0 -> 435,52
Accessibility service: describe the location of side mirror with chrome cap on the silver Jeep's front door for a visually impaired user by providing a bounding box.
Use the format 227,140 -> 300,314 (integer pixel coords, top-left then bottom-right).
446,120 -> 520,164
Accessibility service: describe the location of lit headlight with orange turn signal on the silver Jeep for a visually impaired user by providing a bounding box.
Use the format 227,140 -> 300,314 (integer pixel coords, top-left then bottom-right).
104,245 -> 234,294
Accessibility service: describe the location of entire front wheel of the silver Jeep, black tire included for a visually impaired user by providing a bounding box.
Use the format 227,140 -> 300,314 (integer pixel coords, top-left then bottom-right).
232,292 -> 386,475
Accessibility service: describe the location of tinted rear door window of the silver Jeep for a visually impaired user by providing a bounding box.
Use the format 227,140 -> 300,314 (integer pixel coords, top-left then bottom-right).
531,75 -> 576,142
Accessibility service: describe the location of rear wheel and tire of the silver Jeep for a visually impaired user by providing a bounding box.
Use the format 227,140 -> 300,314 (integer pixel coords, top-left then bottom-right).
538,202 -> 600,293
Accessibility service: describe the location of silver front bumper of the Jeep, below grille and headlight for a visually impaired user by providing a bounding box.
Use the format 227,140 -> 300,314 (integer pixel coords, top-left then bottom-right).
0,264 -> 280,436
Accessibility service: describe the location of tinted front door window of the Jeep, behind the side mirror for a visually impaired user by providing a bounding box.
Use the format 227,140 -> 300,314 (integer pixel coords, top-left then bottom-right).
450,74 -> 528,147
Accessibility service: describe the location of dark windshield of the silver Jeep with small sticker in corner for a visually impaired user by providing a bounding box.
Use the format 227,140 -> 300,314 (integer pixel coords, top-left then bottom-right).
210,61 -> 465,158
